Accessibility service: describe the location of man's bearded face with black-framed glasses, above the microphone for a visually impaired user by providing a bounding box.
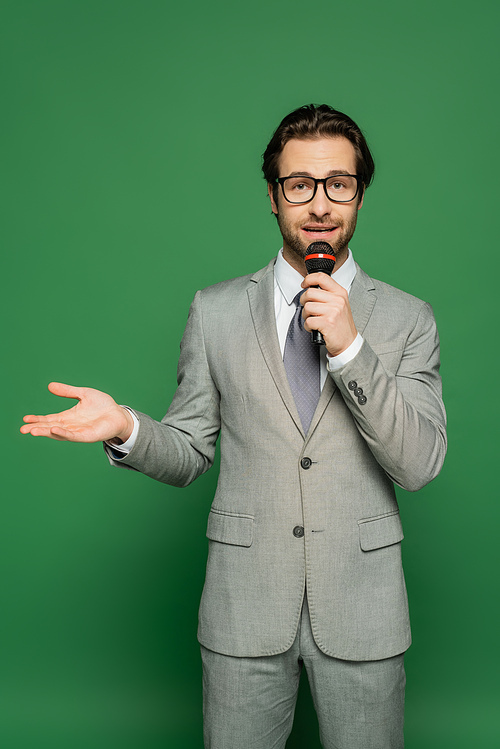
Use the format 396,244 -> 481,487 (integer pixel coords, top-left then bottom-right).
268,136 -> 363,275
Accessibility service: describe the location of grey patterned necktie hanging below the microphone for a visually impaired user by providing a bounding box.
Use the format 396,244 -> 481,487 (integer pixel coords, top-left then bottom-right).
283,290 -> 320,434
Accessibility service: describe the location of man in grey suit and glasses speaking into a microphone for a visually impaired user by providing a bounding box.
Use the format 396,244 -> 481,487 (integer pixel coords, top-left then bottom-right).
21,105 -> 446,749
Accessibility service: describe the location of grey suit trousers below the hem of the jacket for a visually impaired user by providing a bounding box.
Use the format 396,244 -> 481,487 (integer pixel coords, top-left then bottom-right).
201,599 -> 405,749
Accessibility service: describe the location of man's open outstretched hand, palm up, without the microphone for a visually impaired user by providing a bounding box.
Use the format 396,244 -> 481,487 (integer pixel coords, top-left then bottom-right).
21,382 -> 134,442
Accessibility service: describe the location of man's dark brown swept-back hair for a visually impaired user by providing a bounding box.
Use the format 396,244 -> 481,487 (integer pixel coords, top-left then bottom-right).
262,104 -> 375,198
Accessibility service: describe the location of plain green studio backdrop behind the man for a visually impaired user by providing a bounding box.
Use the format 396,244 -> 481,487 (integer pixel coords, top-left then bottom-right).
0,0 -> 500,749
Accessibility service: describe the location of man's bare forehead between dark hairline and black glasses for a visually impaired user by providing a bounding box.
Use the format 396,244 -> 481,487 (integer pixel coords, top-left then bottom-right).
279,136 -> 356,177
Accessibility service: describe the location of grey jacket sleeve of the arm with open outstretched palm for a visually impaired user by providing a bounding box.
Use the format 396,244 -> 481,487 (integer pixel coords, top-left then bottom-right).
105,292 -> 220,486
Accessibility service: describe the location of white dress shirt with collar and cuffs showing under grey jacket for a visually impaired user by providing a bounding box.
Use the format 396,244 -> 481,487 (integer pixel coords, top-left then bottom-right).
106,248 -> 363,458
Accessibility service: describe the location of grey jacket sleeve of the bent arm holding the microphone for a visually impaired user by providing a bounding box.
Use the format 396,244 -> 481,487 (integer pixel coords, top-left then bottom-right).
331,303 -> 446,491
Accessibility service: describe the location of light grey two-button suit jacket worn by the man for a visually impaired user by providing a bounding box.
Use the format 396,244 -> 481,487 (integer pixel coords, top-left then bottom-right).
107,260 -> 446,660
